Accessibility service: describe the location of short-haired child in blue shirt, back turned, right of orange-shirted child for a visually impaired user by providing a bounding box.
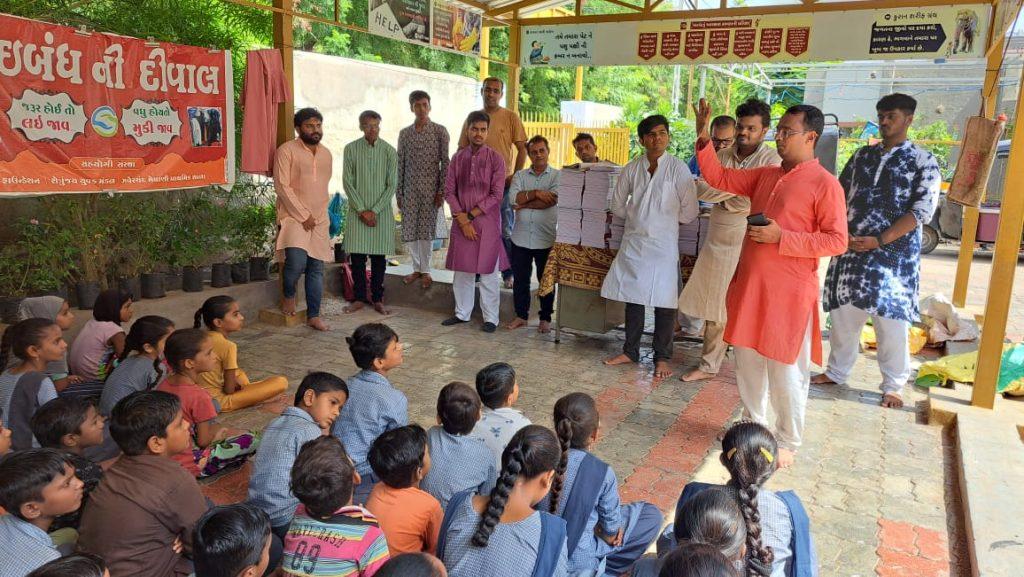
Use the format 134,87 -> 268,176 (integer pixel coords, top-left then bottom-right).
420,382 -> 498,508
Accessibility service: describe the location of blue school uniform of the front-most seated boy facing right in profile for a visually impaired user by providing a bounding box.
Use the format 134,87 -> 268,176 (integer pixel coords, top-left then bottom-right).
331,371 -> 409,504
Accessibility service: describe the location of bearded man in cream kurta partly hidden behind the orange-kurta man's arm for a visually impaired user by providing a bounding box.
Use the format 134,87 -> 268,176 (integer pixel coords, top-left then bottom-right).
679,98 -> 782,381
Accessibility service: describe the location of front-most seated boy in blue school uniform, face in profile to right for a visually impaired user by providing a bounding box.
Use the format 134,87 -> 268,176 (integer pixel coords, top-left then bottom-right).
331,323 -> 409,504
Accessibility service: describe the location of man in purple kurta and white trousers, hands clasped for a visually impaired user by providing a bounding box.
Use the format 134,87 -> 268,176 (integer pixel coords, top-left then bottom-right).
441,111 -> 509,333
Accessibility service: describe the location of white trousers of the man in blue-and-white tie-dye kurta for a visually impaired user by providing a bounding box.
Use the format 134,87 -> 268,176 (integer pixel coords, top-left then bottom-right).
825,304 -> 910,395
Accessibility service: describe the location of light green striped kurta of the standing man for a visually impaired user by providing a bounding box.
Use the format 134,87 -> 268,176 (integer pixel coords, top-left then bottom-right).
342,138 -> 398,254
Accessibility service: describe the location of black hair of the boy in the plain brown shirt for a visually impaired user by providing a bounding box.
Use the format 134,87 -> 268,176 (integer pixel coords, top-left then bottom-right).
109,390 -> 181,456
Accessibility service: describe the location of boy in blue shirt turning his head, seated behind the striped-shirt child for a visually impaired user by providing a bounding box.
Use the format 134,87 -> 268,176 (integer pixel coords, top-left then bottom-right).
249,372 -> 348,567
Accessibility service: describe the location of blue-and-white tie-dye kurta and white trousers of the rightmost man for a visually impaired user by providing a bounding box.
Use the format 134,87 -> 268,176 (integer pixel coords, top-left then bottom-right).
821,140 -> 942,395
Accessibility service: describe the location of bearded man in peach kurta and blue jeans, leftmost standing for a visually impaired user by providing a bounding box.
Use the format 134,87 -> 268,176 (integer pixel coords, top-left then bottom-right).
273,109 -> 333,331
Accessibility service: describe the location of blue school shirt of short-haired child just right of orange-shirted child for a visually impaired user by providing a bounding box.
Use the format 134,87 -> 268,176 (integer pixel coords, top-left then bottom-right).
420,426 -> 498,508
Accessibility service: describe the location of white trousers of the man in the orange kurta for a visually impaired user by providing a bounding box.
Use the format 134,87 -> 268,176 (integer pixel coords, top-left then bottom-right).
734,324 -> 811,451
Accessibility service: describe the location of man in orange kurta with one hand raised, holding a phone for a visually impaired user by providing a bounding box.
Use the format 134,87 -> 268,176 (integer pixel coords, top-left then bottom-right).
696,99 -> 847,466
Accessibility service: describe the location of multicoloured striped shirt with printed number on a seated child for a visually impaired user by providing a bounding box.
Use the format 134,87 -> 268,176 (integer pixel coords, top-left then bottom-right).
282,505 -> 389,577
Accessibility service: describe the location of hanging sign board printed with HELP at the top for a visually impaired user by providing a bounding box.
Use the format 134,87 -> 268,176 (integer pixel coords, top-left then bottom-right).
368,0 -> 483,55
